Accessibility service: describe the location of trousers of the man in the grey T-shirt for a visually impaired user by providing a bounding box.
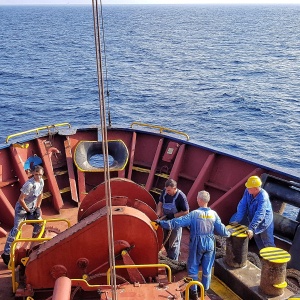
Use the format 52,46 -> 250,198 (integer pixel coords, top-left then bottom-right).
3,202 -> 42,255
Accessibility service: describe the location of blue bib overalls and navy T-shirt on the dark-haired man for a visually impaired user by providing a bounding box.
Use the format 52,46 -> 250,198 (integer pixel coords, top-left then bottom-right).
161,189 -> 189,260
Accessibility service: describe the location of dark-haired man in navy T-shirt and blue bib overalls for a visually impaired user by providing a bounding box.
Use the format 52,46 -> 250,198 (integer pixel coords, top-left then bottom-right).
156,179 -> 189,260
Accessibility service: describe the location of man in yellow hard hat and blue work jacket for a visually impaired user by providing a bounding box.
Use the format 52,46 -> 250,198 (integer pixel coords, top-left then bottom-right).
230,176 -> 275,250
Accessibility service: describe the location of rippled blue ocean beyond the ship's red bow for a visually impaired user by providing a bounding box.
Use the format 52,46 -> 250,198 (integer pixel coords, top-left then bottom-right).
0,5 -> 300,176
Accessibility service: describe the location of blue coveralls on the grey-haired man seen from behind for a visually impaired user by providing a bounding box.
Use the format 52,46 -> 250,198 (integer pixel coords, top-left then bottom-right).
160,207 -> 230,290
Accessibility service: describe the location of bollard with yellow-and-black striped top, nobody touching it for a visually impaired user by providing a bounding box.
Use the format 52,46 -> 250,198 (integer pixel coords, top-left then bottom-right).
259,247 -> 291,296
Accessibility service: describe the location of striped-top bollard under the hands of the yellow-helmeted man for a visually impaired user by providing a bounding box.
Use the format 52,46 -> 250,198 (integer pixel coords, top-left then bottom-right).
225,224 -> 249,268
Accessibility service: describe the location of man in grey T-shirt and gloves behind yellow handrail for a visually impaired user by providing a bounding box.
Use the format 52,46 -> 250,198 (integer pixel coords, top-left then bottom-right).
1,166 -> 44,265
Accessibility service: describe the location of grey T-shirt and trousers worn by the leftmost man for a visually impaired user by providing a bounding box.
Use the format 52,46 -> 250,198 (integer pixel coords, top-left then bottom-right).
3,177 -> 44,255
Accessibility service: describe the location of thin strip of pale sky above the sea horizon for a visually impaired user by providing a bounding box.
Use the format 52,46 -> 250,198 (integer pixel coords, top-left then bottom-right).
0,0 -> 299,5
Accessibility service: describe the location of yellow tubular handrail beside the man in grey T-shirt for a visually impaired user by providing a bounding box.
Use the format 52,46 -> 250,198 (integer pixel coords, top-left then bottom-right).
8,219 -> 71,293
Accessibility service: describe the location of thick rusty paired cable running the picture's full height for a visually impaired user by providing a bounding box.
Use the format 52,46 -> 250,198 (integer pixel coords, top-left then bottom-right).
92,0 -> 117,300
